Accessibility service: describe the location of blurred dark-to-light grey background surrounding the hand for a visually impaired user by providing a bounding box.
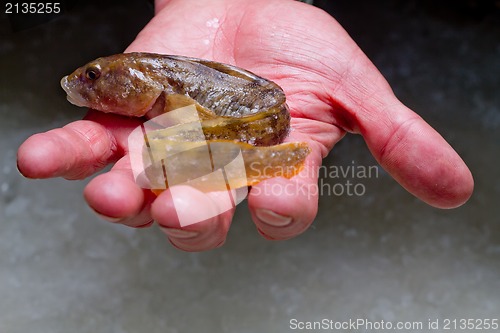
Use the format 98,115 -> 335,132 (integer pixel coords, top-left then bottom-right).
0,0 -> 500,333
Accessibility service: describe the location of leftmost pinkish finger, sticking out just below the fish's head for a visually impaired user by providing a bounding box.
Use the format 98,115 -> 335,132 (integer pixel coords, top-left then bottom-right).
17,111 -> 140,179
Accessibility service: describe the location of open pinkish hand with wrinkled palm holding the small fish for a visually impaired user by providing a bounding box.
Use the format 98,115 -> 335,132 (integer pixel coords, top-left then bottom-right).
18,0 -> 473,251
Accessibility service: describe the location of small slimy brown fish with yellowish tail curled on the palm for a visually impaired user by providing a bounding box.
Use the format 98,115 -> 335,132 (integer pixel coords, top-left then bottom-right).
61,53 -> 310,191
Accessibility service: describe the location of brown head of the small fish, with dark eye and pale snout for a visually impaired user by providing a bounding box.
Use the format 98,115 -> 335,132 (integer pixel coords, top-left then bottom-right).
61,54 -> 163,117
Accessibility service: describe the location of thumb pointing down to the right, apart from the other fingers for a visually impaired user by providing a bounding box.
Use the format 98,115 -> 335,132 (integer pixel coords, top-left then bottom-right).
363,105 -> 474,208
